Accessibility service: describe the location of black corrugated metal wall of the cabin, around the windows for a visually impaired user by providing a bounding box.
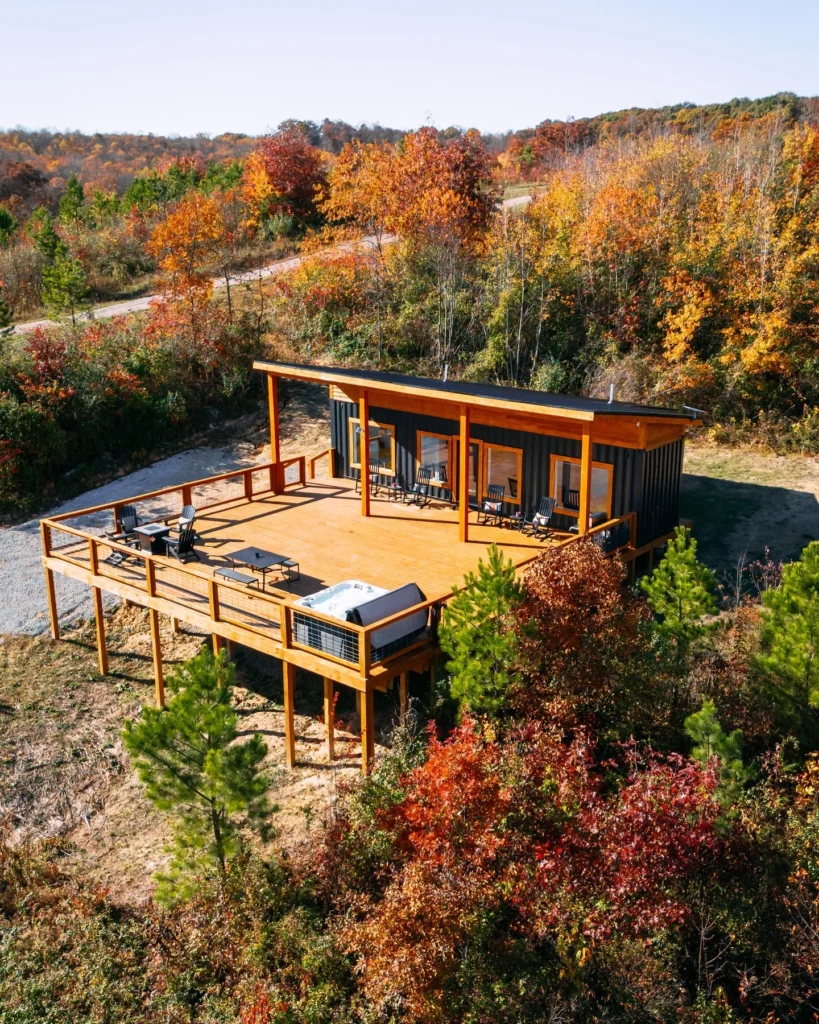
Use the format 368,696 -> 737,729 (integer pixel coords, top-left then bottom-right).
331,400 -> 682,544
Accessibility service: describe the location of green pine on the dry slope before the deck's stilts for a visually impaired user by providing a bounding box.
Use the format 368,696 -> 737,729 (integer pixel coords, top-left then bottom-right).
123,650 -> 269,898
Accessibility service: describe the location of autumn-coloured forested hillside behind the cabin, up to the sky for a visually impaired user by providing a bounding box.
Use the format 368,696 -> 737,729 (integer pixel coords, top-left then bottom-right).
0,94 -> 819,507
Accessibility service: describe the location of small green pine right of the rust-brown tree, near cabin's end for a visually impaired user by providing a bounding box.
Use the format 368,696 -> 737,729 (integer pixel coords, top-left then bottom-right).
640,526 -> 717,658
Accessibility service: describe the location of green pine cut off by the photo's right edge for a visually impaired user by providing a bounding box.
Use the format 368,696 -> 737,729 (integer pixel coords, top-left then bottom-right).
759,541 -> 819,711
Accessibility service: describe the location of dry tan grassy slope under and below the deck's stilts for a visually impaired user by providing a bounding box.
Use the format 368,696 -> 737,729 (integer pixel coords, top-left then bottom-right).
0,607 -> 413,899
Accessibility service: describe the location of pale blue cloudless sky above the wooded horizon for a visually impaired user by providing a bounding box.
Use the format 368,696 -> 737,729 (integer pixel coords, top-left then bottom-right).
0,0 -> 819,134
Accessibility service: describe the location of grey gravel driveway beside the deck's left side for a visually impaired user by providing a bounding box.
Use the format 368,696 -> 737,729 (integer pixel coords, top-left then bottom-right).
0,442 -> 267,635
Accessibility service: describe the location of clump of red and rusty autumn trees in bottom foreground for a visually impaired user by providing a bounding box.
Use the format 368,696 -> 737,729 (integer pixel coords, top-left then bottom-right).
346,722 -> 724,1022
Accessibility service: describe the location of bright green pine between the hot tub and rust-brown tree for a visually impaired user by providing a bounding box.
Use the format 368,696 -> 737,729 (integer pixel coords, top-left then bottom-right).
439,545 -> 522,716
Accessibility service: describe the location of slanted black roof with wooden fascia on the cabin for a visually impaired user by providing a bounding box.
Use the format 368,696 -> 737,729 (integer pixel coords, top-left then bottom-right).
256,360 -> 698,420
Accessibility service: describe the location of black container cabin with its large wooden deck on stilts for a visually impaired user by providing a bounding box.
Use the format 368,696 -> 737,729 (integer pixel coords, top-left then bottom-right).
41,362 -> 696,770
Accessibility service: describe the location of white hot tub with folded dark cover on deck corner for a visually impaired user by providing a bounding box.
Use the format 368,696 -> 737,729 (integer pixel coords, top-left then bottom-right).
293,580 -> 429,663
